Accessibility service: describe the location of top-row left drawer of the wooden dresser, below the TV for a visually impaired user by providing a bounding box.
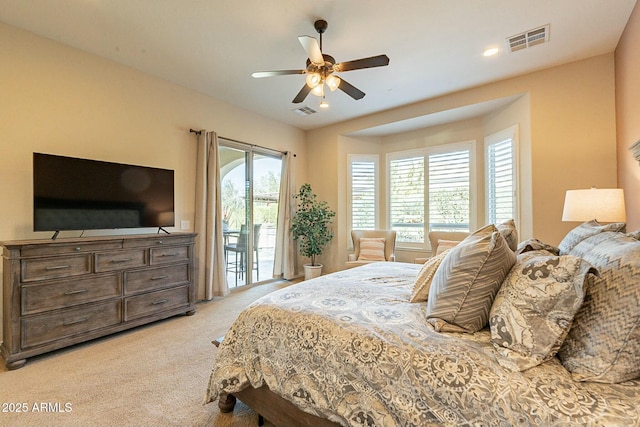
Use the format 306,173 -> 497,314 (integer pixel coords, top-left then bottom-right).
20,254 -> 91,282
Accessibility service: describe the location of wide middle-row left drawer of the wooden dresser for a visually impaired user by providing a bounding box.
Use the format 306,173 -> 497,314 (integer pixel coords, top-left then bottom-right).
21,274 -> 122,315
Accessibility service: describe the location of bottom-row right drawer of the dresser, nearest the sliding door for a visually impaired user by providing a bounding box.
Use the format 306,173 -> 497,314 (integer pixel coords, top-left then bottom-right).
124,286 -> 189,322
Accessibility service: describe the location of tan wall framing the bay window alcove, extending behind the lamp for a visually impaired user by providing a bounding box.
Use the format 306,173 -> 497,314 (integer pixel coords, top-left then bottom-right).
307,53 -> 617,271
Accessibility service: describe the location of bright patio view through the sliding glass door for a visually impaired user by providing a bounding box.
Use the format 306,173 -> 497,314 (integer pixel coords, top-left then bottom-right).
219,142 -> 282,289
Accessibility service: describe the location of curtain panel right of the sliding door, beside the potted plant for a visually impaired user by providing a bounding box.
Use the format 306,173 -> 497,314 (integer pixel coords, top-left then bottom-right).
273,153 -> 297,280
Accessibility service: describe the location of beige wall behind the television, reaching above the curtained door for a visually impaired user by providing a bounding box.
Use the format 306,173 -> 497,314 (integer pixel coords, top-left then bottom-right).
0,24 -> 306,340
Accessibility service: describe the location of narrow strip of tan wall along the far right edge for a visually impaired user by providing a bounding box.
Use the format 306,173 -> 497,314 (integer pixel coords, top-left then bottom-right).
615,4 -> 640,231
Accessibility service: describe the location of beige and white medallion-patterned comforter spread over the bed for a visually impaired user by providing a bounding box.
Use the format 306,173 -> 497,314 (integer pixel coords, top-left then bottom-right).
207,262 -> 640,427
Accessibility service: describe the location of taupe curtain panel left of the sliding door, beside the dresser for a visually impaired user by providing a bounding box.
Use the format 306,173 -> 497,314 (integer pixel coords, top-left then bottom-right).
195,129 -> 229,300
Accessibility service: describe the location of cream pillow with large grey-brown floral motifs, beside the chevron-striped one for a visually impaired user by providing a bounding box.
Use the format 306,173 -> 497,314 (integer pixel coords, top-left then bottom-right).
489,250 -> 596,371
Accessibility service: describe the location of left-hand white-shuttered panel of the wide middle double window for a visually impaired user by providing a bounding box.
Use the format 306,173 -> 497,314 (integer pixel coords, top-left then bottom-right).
389,154 -> 425,243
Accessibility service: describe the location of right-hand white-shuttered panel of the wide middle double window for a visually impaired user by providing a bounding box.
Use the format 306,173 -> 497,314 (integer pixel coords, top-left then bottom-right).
429,149 -> 471,231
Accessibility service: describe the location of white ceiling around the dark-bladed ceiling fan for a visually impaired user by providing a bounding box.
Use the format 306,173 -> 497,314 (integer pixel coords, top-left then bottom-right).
0,0 -> 636,134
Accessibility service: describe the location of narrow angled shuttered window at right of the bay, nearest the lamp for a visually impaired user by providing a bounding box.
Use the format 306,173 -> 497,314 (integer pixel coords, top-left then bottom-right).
486,127 -> 517,224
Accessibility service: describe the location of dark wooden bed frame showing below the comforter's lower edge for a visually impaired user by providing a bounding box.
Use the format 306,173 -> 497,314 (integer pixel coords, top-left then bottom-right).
212,337 -> 340,427
